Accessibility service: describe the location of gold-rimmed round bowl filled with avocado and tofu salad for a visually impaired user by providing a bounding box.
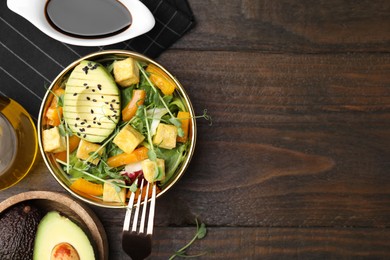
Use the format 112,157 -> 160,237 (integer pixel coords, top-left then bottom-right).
38,50 -> 196,208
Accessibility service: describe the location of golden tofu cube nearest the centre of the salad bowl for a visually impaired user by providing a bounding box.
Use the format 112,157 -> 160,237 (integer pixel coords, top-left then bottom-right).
113,125 -> 145,153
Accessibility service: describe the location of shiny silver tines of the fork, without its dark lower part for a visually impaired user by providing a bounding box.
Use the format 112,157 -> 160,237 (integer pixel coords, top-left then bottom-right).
123,179 -> 156,235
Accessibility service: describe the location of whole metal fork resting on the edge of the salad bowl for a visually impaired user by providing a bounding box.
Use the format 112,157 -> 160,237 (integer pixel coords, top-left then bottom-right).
122,179 -> 156,260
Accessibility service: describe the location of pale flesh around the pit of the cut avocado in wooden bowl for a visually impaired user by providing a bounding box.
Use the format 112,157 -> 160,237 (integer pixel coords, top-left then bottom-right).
33,211 -> 96,260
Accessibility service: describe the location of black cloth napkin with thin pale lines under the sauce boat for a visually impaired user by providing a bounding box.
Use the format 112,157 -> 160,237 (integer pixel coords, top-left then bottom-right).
0,0 -> 195,118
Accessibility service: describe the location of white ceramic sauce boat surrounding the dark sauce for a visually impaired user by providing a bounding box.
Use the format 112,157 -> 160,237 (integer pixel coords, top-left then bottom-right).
7,0 -> 155,46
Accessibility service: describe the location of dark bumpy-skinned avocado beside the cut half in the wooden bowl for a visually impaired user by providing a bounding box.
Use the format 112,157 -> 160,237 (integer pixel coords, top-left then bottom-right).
0,203 -> 43,260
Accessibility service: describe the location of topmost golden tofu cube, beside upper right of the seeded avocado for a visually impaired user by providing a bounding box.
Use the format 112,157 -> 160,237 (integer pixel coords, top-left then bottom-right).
114,58 -> 139,87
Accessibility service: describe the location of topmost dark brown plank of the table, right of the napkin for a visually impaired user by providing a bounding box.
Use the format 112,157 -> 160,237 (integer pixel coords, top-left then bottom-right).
175,0 -> 390,53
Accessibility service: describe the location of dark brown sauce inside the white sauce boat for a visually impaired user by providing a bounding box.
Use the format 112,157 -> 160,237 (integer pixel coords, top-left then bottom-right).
45,0 -> 132,38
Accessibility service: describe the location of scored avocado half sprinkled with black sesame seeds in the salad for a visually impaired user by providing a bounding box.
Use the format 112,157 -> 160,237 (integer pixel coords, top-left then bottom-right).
63,61 -> 120,143
